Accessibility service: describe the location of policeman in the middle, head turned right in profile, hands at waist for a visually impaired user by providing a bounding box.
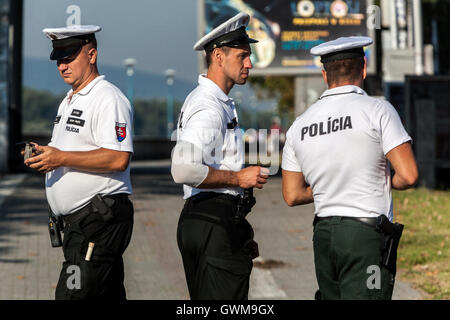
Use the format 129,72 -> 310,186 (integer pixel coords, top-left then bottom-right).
172,13 -> 268,300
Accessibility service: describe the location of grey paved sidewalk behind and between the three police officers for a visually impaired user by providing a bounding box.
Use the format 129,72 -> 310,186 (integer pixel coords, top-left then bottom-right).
0,161 -> 420,300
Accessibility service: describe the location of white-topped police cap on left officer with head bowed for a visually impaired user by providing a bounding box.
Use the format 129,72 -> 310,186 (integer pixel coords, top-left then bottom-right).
42,25 -> 102,60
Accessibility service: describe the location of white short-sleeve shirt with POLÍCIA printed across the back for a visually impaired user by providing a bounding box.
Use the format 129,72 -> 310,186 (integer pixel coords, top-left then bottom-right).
282,85 -> 411,221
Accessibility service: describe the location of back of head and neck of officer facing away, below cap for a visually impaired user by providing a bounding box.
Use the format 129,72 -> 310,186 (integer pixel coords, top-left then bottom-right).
323,57 -> 366,85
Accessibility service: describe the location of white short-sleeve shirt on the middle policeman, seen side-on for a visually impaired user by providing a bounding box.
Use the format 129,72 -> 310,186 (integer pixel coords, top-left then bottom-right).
177,75 -> 244,199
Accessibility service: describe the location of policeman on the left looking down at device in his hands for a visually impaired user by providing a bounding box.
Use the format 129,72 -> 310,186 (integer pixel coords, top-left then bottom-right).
25,25 -> 133,299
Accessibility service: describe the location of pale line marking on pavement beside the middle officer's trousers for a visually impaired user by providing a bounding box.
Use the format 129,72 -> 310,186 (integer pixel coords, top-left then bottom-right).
249,257 -> 287,299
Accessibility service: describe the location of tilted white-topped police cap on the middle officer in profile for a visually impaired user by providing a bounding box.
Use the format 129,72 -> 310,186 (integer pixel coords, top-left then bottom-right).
194,12 -> 258,52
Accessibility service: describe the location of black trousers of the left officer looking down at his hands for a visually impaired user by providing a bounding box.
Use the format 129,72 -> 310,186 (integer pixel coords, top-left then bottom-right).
55,197 -> 134,300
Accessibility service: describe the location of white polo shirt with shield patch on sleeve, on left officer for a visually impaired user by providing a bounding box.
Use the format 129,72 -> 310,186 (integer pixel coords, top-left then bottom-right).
45,76 -> 133,215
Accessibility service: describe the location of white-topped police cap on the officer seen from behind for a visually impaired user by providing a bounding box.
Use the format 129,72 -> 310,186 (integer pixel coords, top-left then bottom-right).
311,37 -> 373,63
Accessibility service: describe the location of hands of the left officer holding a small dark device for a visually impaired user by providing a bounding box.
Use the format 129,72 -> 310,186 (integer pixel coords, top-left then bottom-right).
25,143 -> 63,173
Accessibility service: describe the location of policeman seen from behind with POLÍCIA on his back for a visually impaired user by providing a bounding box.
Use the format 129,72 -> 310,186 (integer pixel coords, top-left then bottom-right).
282,37 -> 418,299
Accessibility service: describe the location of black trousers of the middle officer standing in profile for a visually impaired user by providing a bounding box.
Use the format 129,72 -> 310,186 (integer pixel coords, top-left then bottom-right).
177,194 -> 253,300
